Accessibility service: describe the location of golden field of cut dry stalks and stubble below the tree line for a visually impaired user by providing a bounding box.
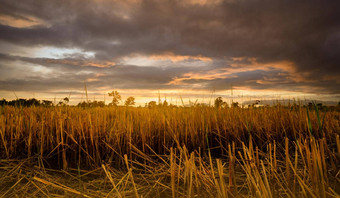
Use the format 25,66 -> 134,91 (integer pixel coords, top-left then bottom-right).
0,105 -> 340,197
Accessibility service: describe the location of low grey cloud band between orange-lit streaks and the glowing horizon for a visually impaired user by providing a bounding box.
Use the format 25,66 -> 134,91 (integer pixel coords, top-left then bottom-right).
0,54 -> 338,94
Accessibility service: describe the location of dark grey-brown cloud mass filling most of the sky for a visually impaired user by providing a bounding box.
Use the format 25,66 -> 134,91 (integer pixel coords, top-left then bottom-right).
0,0 -> 340,97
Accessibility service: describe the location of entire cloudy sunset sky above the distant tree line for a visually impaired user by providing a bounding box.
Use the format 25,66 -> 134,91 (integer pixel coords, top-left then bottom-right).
0,0 -> 340,104
